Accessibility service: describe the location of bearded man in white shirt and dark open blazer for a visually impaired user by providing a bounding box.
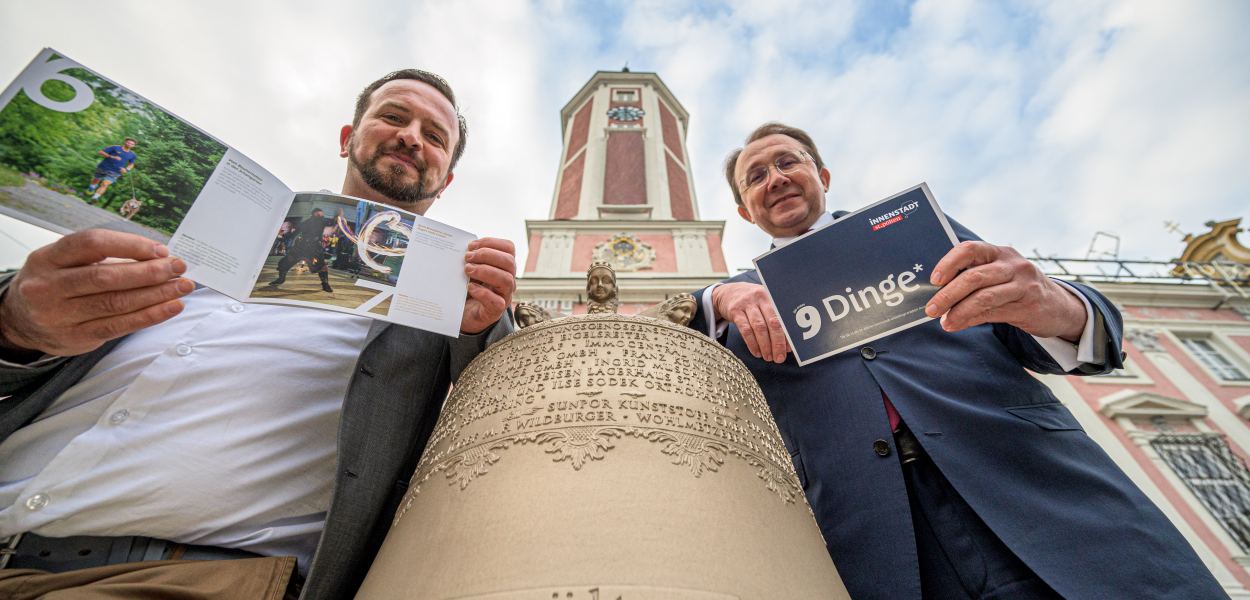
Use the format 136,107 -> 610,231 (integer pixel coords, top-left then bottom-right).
0,69 -> 515,599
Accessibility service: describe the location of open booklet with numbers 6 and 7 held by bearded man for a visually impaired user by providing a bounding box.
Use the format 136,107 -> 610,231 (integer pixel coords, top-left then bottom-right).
0,49 -> 475,336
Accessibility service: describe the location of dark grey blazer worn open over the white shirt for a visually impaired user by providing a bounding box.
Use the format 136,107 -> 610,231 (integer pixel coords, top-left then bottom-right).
0,272 -> 511,600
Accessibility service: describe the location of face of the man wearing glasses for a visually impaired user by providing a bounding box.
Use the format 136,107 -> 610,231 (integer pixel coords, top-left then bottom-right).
734,134 -> 829,238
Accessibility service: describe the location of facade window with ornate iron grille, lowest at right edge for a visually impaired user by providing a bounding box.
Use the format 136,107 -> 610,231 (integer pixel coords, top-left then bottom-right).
1150,434 -> 1250,553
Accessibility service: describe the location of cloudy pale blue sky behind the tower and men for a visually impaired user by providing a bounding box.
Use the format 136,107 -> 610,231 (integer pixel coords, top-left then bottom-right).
0,0 -> 1250,270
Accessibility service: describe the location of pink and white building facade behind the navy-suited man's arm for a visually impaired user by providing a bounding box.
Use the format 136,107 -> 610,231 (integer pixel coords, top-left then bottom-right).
1035,219 -> 1250,599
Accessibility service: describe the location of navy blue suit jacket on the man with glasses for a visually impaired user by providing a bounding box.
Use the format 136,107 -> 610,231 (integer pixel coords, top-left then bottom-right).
690,214 -> 1226,600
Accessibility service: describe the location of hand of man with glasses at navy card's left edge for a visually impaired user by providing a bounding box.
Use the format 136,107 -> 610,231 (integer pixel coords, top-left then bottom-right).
711,281 -> 789,364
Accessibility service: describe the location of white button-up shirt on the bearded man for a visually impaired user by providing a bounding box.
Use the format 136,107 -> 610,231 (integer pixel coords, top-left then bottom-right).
0,289 -> 371,571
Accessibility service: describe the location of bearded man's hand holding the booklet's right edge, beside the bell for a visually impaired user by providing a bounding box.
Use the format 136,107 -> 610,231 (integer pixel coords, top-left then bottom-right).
460,238 -> 516,334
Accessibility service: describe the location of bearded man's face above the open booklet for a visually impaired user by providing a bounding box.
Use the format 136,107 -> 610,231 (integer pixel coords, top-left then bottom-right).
340,79 -> 459,213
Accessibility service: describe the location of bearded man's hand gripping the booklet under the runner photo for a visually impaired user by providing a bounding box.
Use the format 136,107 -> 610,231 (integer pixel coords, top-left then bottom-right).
0,229 -> 195,356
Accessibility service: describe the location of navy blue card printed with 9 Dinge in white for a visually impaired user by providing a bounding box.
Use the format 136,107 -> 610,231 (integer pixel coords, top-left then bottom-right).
755,184 -> 959,366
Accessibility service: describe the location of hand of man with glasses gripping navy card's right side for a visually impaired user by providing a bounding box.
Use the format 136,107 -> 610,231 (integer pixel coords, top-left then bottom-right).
925,241 -> 1085,341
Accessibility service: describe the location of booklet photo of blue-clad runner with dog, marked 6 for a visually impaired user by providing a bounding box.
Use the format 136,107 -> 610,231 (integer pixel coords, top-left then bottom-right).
0,50 -> 226,241
